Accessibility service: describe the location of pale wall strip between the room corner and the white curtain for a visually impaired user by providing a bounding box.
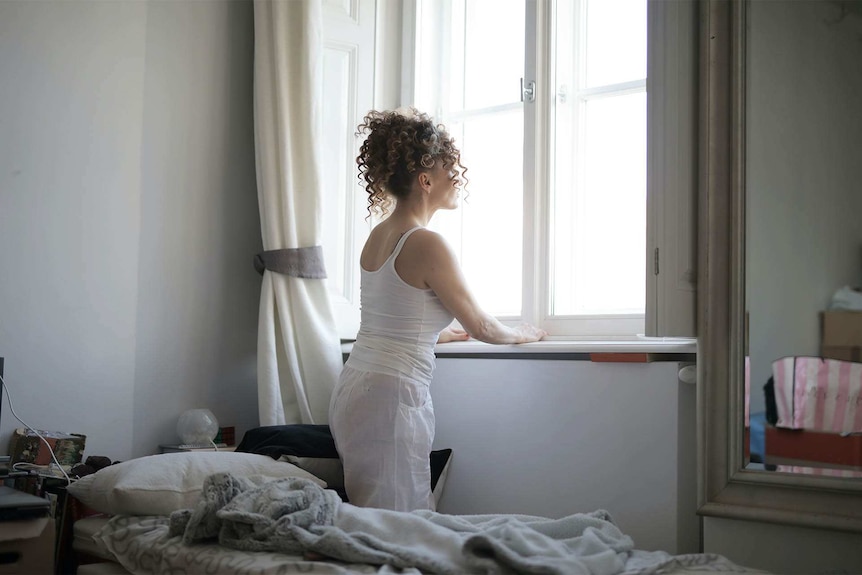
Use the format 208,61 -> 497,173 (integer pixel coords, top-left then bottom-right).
134,0 -> 262,460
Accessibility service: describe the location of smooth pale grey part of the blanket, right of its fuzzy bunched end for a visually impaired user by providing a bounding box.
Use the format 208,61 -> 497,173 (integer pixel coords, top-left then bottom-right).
324,505 -> 633,575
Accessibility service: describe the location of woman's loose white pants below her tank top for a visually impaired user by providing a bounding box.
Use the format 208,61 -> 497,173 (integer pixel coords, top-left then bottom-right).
329,367 -> 434,511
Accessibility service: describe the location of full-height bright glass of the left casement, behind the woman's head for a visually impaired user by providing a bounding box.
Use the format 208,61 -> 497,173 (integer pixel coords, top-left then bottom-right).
415,0 -> 526,317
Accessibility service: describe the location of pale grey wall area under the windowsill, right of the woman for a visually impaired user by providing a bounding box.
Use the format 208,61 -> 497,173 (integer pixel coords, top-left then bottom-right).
431,358 -> 700,553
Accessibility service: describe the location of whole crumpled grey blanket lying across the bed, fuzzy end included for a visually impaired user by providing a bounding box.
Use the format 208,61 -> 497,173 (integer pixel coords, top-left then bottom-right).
169,473 -> 633,575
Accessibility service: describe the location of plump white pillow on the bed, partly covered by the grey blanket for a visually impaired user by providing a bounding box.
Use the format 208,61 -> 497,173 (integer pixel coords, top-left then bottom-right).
68,451 -> 326,515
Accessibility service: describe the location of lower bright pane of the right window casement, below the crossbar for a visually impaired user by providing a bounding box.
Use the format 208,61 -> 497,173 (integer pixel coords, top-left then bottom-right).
551,92 -> 646,315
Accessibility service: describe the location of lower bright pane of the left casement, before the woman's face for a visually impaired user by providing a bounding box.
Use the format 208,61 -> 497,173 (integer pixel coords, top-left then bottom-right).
430,109 -> 524,316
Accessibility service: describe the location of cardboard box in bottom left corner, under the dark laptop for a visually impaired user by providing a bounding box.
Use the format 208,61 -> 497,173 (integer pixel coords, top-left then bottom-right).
0,517 -> 56,575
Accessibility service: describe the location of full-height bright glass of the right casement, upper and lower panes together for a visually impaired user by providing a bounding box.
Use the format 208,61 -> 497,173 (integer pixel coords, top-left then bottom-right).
547,0 -> 646,319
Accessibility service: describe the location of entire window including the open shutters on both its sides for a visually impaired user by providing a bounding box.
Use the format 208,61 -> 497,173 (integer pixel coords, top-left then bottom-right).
323,0 -> 697,338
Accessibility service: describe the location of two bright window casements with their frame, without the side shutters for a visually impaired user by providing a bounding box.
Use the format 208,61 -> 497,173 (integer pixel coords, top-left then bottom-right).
413,0 -> 647,335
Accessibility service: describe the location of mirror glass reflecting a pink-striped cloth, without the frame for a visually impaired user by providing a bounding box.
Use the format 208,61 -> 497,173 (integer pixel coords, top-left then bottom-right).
743,0 -> 862,479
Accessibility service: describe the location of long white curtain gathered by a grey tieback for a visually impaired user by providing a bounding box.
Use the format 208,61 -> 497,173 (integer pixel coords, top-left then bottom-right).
254,0 -> 341,425
